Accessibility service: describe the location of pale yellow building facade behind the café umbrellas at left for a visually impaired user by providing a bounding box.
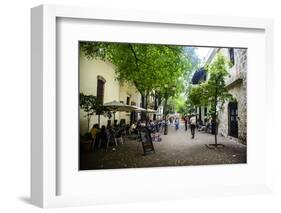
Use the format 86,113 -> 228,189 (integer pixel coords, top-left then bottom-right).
79,51 -> 141,134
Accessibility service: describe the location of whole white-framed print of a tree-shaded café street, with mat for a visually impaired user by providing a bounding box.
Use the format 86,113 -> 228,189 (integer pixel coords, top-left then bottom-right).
31,5 -> 273,207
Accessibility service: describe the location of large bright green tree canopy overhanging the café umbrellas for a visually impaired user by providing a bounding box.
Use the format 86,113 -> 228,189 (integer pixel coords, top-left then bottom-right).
80,42 -> 192,101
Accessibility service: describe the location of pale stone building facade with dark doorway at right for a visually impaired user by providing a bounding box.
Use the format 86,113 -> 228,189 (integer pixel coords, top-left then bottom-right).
192,48 -> 247,144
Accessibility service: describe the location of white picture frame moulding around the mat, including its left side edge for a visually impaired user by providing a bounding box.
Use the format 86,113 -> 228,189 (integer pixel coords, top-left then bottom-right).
31,5 -> 274,208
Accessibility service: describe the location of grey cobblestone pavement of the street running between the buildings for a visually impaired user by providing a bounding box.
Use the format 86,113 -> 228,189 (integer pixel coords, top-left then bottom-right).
80,125 -> 246,170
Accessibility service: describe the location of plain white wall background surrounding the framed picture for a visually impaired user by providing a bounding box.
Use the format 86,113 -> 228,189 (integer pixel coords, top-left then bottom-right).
0,0 -> 281,213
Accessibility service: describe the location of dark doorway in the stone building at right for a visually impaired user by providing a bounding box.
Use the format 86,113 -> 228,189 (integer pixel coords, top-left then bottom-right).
228,102 -> 238,138
